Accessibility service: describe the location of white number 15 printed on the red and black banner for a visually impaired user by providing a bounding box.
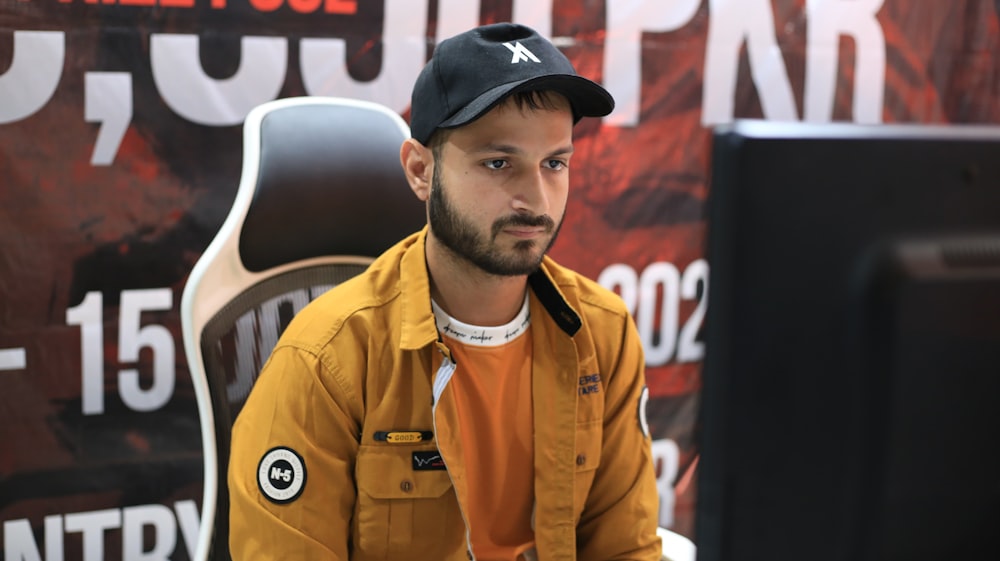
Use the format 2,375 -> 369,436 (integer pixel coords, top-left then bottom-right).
66,288 -> 176,415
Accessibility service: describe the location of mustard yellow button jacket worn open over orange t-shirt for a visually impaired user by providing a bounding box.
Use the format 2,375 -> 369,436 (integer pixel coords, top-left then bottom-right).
229,229 -> 660,561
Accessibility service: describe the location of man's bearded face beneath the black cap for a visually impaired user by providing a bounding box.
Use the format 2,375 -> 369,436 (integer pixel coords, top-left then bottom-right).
428,95 -> 573,276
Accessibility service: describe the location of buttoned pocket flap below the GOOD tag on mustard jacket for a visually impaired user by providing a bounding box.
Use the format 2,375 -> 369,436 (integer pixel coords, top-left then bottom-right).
354,445 -> 451,499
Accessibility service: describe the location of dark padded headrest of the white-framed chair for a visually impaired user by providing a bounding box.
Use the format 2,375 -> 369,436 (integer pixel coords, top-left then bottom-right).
240,102 -> 426,272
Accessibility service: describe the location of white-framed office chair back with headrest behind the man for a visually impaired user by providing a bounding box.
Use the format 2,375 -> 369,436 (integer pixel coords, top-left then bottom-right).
181,97 -> 426,561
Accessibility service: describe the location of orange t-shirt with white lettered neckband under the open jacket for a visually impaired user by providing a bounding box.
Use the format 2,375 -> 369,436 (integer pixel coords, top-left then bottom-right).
434,296 -> 535,561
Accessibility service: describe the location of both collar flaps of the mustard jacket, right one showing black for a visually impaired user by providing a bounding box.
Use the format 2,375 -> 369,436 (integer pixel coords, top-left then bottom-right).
399,226 -> 582,350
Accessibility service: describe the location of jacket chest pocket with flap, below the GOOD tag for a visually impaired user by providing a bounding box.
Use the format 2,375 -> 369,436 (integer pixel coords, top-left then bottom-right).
352,444 -> 464,559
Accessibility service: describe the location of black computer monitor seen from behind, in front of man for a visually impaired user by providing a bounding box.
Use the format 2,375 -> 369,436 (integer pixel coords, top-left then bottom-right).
695,121 -> 1000,561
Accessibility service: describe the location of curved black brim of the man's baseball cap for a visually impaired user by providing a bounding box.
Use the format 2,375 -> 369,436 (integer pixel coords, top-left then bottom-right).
438,74 -> 615,128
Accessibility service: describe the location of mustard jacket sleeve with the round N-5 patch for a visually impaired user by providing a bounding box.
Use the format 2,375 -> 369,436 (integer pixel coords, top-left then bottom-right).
228,346 -> 361,561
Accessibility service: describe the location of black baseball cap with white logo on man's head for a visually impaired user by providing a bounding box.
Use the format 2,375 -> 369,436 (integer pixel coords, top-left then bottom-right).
410,23 -> 615,144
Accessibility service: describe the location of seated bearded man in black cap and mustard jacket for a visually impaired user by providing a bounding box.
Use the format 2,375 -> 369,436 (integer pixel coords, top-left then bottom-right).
229,24 -> 660,561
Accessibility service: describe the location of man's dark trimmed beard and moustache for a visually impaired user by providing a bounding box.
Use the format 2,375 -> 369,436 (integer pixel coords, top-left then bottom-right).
428,166 -> 562,277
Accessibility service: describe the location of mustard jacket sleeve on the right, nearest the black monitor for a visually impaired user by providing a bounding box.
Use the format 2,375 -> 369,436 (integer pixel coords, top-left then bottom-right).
577,314 -> 662,561
